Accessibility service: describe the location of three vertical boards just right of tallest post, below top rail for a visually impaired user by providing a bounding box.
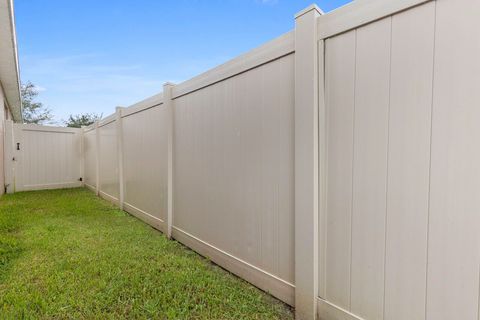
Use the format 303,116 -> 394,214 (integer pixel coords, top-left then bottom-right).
319,3 -> 435,319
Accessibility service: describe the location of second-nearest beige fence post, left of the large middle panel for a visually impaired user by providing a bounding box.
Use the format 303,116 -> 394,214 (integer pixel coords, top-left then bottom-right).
163,82 -> 174,238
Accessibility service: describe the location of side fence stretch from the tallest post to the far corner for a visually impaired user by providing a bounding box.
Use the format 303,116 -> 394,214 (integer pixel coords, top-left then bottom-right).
84,29 -> 295,304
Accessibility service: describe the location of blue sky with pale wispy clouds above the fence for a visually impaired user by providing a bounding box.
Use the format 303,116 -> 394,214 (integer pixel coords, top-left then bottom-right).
15,0 -> 349,123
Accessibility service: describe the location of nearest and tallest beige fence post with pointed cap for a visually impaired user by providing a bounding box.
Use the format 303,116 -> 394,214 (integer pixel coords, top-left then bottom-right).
295,5 -> 322,319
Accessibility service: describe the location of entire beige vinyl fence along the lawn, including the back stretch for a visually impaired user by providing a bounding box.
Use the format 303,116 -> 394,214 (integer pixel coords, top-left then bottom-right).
7,0 -> 480,320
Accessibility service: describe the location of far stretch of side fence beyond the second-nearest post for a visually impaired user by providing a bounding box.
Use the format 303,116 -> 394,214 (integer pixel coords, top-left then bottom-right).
84,96 -> 168,232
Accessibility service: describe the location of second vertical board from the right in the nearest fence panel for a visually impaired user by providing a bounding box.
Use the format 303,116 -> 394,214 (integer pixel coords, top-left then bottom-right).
384,2 -> 435,319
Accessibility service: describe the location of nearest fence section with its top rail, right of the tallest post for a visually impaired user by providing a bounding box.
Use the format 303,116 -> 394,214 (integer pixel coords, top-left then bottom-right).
318,0 -> 480,320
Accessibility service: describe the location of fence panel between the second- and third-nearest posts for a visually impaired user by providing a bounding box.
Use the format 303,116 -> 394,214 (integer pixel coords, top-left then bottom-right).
122,104 -> 168,232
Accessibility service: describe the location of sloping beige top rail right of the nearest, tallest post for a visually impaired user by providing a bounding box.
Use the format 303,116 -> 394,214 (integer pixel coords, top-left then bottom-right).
317,0 -> 433,40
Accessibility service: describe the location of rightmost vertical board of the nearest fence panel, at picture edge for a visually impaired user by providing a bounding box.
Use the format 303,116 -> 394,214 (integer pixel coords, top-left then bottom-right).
427,0 -> 480,320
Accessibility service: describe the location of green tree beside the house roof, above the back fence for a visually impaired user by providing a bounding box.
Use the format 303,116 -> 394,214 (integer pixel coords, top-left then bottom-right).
20,81 -> 53,124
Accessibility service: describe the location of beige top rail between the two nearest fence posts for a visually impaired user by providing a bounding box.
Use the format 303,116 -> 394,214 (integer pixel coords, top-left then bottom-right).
172,31 -> 295,99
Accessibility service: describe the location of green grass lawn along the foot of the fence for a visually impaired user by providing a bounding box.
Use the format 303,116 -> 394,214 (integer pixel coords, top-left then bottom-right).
0,189 -> 293,319
